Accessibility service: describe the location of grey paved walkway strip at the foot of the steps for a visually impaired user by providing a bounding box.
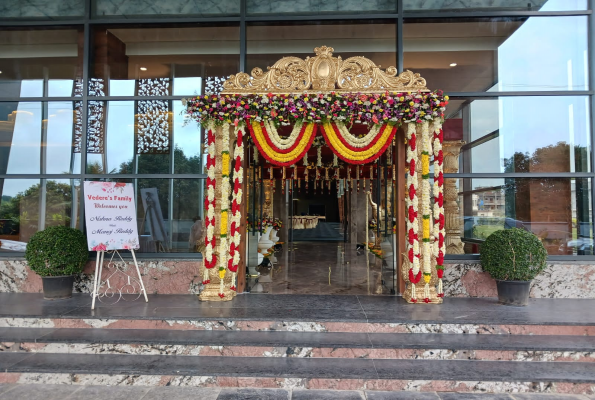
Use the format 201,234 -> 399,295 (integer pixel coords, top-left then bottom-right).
0,384 -> 595,400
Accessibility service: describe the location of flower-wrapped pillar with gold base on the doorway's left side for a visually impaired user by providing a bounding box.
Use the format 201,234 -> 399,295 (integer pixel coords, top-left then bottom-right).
199,123 -> 237,301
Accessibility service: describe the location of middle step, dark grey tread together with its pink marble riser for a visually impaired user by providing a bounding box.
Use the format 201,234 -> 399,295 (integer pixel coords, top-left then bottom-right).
0,328 -> 595,362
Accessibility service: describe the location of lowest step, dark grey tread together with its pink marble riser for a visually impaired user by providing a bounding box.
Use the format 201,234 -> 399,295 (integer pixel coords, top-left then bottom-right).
0,353 -> 595,394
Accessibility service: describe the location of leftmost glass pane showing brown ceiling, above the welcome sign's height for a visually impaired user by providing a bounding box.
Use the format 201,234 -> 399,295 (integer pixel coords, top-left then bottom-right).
0,27 -> 83,98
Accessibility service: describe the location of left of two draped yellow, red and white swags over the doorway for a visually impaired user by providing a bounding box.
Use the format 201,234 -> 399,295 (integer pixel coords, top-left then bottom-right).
248,121 -> 317,167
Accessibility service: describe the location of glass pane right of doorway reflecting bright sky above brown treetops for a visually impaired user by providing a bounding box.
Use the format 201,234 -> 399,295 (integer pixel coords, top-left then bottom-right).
444,96 -> 592,173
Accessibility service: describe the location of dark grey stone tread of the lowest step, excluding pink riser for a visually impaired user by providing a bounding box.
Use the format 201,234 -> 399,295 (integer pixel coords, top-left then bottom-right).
0,353 -> 595,384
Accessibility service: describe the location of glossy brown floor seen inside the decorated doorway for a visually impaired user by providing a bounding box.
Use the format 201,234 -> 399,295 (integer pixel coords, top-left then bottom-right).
248,242 -> 397,294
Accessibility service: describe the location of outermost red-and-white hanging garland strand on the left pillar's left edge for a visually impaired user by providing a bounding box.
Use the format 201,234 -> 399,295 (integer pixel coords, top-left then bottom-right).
202,124 -> 217,285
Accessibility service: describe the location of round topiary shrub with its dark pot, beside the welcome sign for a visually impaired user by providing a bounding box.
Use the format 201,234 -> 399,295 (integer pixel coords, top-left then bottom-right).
25,226 -> 89,300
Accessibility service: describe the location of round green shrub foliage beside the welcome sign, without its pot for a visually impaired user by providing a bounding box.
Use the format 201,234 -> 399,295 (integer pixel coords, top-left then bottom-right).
25,226 -> 89,276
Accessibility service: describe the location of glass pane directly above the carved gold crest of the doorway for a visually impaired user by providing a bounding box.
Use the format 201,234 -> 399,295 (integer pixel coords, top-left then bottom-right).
247,21 -> 397,71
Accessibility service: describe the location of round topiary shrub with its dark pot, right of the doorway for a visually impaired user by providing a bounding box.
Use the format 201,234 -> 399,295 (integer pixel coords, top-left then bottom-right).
480,228 -> 547,306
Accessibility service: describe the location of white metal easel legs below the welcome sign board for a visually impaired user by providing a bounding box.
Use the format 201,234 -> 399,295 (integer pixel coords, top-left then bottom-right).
91,249 -> 149,310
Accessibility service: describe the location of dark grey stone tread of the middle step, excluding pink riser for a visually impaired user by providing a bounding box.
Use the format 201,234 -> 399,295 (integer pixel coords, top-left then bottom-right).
0,327 -> 595,352
